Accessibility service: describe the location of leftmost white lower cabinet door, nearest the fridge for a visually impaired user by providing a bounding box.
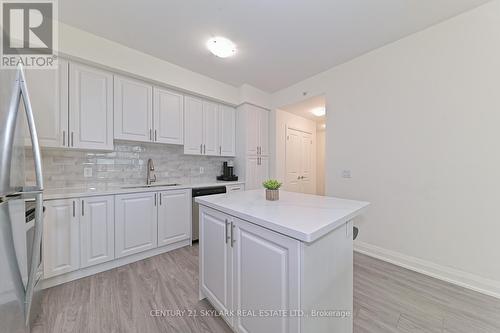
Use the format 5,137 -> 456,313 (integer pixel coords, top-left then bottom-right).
42,199 -> 80,278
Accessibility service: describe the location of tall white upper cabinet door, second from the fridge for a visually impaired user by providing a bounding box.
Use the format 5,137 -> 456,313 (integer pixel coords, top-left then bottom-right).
69,63 -> 113,150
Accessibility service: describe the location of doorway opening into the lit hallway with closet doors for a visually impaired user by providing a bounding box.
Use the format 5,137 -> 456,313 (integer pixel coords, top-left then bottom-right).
275,95 -> 326,195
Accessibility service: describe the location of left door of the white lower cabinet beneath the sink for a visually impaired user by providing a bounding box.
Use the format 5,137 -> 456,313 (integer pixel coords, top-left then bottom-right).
115,192 -> 158,258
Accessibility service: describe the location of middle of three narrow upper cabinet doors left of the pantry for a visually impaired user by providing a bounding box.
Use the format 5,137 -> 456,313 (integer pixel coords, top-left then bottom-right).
203,101 -> 219,156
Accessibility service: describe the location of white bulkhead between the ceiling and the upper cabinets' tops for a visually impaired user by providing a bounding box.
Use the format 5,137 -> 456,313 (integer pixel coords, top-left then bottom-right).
59,23 -> 270,108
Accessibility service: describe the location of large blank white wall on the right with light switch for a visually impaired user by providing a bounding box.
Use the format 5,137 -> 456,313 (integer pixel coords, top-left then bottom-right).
273,0 -> 500,297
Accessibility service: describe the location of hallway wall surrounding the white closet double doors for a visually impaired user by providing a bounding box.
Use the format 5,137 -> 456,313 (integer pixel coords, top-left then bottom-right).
270,110 -> 316,193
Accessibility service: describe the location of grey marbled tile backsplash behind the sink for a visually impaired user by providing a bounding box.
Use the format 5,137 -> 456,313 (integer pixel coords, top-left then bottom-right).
26,141 -> 231,188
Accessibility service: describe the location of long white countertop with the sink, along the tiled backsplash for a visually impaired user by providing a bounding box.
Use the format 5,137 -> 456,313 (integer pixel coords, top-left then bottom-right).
43,181 -> 245,200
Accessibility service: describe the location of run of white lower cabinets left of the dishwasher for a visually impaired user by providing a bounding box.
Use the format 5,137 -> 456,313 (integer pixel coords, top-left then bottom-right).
42,189 -> 192,286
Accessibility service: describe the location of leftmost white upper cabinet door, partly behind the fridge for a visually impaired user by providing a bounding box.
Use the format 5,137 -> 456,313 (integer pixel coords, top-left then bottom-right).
25,59 -> 69,147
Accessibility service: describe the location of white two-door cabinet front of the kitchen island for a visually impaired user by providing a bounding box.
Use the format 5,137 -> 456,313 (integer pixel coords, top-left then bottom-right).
200,206 -> 300,333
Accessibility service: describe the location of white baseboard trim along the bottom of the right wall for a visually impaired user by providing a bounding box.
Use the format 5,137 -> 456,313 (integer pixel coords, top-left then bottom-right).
354,241 -> 500,299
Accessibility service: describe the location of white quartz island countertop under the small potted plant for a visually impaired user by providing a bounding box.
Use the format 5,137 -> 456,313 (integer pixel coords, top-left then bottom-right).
196,189 -> 369,243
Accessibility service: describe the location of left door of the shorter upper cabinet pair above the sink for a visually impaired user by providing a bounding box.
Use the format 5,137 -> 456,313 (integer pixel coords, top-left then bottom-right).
114,75 -> 153,142
